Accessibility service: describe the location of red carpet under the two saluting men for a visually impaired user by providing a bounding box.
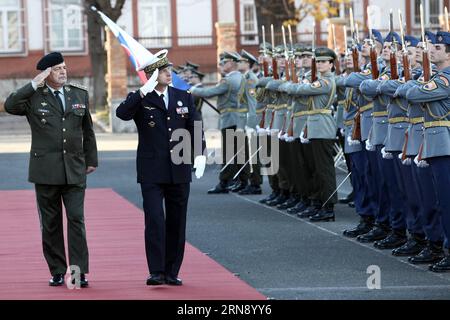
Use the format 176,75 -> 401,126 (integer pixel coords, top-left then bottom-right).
0,189 -> 265,300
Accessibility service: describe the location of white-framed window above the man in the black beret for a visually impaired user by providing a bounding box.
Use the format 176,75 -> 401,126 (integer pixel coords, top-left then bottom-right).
47,0 -> 85,52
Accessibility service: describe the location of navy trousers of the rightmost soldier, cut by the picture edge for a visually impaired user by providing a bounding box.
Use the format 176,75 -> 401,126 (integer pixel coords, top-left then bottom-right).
426,156 -> 450,248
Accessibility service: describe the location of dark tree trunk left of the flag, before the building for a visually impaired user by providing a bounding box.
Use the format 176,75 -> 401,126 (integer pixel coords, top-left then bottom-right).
84,0 -> 126,110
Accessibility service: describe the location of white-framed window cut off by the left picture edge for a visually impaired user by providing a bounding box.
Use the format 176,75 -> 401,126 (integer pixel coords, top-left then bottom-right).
0,0 -> 25,53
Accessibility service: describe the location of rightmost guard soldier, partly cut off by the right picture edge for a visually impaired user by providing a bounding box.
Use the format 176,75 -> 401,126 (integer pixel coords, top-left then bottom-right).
406,31 -> 450,272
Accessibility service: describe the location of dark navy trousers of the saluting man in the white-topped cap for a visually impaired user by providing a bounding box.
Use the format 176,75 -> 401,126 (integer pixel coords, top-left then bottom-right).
141,183 -> 190,277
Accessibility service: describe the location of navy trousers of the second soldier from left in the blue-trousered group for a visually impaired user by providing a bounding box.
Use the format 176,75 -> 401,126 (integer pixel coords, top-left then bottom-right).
363,146 -> 389,224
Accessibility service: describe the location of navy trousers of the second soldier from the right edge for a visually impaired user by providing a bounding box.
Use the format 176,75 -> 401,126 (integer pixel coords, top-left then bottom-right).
411,159 -> 444,242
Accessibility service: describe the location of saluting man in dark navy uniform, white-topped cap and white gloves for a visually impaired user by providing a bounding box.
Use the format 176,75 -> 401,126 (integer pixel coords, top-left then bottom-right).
116,54 -> 206,286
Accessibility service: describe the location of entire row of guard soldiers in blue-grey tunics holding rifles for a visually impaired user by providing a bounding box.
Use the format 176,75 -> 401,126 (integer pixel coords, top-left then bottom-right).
188,26 -> 450,272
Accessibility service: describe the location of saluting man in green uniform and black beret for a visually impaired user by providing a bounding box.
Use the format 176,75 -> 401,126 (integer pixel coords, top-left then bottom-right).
5,52 -> 98,287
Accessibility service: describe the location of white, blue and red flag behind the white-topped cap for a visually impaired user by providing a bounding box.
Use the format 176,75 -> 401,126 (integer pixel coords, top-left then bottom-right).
91,6 -> 191,90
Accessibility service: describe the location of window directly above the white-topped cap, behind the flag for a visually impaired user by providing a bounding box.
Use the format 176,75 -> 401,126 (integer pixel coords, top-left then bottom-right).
138,0 -> 172,48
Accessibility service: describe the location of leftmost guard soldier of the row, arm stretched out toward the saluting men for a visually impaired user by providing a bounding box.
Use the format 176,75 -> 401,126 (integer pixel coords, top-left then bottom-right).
192,52 -> 247,194
